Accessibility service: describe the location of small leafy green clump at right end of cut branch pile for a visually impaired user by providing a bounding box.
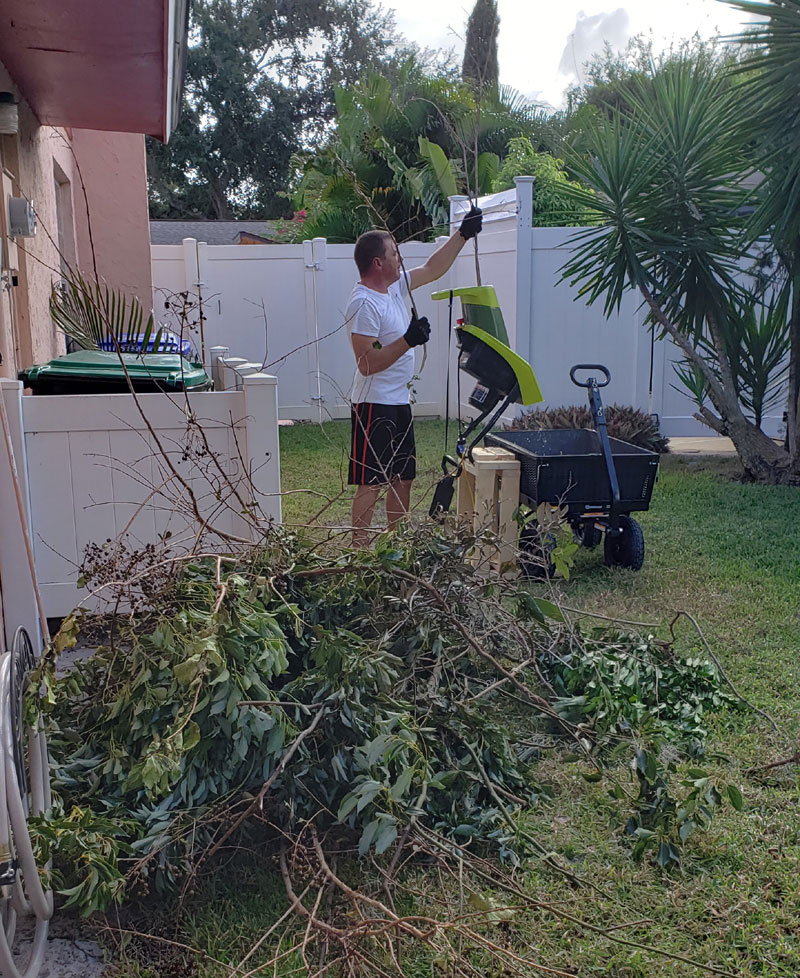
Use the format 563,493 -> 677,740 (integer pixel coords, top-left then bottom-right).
542,629 -> 743,869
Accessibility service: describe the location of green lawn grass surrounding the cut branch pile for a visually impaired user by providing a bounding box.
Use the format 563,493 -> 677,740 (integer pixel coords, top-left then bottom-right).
112,422 -> 800,978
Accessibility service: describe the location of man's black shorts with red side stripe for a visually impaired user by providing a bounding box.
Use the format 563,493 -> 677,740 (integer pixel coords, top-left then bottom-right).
347,401 -> 417,486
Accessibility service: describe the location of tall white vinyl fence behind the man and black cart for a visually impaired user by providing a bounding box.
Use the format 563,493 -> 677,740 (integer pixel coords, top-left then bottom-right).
152,177 -> 781,436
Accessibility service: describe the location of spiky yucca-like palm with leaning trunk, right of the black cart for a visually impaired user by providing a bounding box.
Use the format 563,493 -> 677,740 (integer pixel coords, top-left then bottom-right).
562,56 -> 800,482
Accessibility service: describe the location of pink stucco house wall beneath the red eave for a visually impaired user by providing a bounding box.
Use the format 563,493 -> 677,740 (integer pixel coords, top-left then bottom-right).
0,56 -> 152,377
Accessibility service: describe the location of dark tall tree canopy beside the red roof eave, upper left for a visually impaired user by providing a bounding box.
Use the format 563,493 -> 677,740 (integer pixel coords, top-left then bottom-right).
148,0 -> 416,218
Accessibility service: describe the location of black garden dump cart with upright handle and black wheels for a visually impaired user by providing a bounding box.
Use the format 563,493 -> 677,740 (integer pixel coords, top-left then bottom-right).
486,363 -> 659,574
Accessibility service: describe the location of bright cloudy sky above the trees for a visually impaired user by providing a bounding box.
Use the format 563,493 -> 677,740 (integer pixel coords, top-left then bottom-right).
388,0 -> 746,106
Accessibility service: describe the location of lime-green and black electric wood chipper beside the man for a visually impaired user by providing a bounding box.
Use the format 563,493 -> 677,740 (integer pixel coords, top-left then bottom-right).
430,285 -> 543,516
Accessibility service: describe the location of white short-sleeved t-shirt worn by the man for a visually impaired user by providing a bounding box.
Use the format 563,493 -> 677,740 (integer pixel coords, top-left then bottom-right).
345,278 -> 414,404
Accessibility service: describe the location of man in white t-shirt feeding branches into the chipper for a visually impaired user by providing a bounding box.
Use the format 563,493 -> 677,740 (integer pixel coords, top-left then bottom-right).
346,207 -> 482,547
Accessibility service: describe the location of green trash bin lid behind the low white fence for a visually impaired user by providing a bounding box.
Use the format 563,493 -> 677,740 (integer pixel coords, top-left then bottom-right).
19,350 -> 211,394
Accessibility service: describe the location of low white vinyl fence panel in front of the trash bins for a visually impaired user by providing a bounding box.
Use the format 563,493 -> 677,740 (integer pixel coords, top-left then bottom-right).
0,372 -> 281,634
